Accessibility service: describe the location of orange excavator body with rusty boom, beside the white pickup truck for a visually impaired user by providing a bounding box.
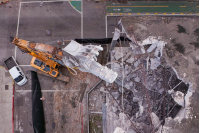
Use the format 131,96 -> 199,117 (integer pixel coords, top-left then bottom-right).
12,37 -> 64,77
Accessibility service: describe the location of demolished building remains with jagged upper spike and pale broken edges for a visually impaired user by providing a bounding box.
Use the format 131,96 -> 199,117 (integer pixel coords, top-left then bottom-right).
100,18 -> 196,133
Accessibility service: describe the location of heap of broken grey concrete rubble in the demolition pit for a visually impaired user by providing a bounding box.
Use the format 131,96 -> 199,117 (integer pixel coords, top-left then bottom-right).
107,37 -> 189,132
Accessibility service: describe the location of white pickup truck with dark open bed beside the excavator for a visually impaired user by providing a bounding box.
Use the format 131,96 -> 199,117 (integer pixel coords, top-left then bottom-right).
4,56 -> 28,86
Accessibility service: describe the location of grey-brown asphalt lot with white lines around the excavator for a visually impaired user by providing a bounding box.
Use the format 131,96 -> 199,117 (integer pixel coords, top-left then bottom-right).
0,1 -> 106,133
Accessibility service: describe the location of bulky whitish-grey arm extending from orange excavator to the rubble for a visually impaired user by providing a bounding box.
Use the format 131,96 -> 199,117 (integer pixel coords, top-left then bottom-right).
62,40 -> 117,83
